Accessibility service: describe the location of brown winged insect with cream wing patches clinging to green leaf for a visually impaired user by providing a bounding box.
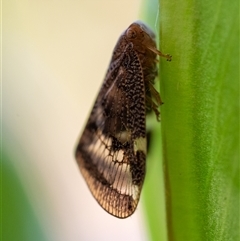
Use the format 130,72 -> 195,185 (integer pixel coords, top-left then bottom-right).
76,21 -> 171,218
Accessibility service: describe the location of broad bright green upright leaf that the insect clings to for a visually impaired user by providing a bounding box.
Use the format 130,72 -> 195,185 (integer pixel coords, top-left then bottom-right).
144,0 -> 240,241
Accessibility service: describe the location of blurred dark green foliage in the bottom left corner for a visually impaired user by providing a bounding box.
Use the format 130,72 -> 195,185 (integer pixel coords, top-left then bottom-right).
0,154 -> 46,241
